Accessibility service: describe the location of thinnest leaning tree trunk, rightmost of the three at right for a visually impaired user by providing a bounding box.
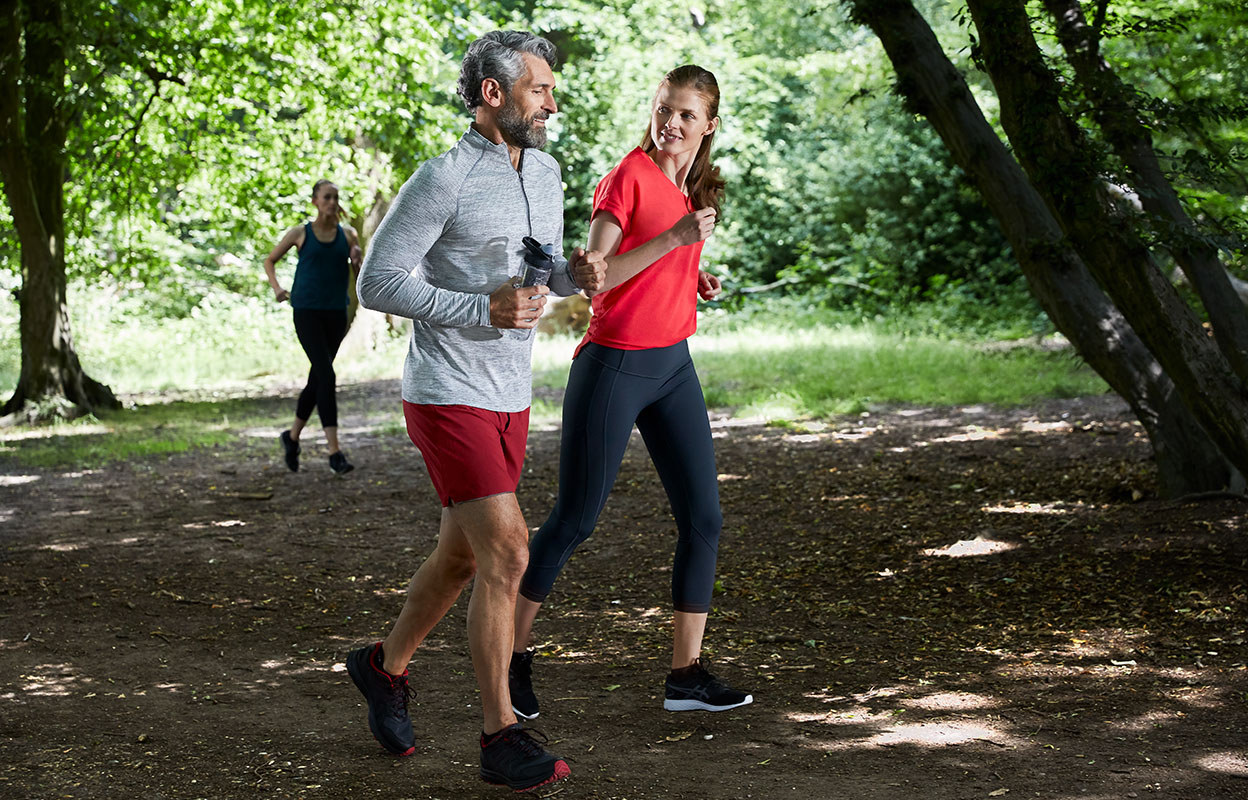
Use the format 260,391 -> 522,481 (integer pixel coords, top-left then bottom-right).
1045,0 -> 1248,381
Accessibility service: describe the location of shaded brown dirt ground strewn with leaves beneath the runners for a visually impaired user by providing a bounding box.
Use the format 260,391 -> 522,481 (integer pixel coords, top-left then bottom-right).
0,384 -> 1248,800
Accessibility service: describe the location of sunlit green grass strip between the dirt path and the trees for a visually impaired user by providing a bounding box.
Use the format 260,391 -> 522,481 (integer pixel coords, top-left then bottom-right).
0,287 -> 1107,468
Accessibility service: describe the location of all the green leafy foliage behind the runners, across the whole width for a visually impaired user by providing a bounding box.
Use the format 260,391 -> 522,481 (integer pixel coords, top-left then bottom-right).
0,0 -> 1248,379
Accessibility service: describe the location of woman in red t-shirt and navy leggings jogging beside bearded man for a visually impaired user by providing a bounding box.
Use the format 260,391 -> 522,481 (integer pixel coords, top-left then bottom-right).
509,65 -> 754,719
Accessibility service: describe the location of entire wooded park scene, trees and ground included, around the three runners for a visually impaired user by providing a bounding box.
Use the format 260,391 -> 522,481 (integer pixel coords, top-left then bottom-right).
0,0 -> 1248,800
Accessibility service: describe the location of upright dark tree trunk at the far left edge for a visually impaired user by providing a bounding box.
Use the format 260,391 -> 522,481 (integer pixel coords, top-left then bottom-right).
0,0 -> 120,418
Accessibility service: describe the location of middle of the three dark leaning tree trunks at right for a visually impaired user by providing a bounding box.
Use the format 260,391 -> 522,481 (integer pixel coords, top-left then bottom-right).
967,0 -> 1248,474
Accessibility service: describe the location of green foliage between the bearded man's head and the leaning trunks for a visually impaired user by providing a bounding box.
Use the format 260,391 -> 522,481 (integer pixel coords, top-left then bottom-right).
529,1 -> 1036,321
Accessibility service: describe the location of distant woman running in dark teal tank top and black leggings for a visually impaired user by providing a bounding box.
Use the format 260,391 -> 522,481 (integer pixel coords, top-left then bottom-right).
265,180 -> 363,476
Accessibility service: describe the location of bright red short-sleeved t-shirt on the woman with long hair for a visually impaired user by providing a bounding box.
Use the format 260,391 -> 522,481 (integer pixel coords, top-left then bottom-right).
577,147 -> 703,352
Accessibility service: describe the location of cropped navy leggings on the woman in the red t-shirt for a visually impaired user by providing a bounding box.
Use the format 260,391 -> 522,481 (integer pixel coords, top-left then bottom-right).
520,342 -> 723,614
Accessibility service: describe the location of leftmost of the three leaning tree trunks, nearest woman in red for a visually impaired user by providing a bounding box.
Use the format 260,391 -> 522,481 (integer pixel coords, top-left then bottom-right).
847,0 -> 1238,495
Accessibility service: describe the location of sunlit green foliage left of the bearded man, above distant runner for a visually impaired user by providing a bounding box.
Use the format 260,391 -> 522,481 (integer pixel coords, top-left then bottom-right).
35,0 -> 493,316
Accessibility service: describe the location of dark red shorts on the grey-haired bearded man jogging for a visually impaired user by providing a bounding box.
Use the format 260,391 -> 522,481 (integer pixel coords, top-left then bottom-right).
403,401 -> 529,507
